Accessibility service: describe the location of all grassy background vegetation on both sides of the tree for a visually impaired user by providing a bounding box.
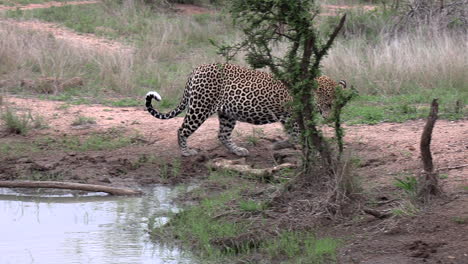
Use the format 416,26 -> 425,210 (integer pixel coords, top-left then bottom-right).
0,1 -> 468,121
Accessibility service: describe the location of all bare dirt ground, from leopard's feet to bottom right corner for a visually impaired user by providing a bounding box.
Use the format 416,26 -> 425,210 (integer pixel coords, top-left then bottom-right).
0,97 -> 468,263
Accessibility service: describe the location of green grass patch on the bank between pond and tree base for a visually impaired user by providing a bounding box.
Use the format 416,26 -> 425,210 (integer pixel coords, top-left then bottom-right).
152,171 -> 339,263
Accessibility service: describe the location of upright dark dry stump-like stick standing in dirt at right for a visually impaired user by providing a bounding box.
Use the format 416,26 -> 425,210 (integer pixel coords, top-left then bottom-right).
418,99 -> 441,201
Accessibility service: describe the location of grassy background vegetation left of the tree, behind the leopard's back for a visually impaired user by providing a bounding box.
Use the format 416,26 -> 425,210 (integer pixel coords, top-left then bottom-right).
0,1 -> 235,107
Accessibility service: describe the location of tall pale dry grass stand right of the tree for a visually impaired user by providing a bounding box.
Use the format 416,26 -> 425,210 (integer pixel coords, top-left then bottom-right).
324,32 -> 468,95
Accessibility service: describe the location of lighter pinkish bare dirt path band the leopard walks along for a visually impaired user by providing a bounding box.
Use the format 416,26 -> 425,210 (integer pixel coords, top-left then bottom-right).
4,97 -> 468,189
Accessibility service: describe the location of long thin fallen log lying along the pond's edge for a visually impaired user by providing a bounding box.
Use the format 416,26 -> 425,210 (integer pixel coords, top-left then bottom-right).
0,181 -> 142,196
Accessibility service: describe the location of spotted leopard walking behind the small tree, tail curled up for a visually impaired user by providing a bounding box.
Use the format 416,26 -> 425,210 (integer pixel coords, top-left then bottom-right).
146,63 -> 346,156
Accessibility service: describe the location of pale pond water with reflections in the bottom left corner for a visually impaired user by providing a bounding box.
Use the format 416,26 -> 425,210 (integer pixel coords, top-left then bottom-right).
0,186 -> 194,264
